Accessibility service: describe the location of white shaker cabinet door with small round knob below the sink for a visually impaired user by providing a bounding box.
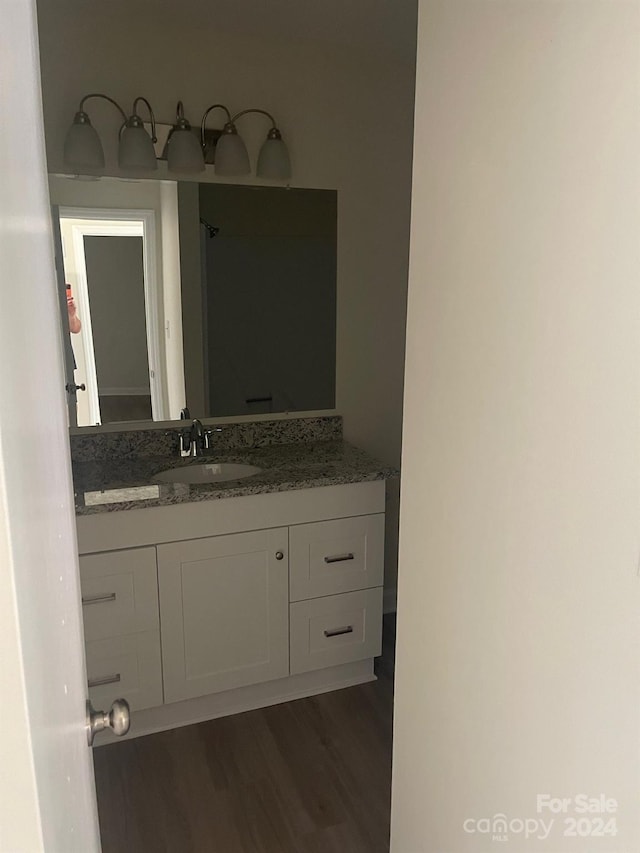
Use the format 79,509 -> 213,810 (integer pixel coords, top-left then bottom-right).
157,527 -> 289,702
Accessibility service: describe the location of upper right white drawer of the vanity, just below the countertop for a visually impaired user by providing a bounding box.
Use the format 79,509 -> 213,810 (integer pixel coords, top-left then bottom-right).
289,513 -> 384,601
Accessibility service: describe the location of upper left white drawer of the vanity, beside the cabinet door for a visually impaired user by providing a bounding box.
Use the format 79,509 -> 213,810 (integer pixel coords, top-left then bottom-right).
80,548 -> 159,642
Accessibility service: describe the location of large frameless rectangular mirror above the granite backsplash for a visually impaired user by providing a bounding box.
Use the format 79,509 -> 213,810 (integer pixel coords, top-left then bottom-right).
50,176 -> 337,426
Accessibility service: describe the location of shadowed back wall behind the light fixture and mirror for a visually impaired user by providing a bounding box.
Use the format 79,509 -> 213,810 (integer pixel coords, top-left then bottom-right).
39,0 -> 415,600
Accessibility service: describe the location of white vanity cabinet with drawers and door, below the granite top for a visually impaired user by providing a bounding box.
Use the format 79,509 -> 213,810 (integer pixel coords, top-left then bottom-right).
77,481 -> 385,736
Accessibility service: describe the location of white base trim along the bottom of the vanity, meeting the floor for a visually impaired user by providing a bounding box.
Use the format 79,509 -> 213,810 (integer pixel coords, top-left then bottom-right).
93,658 -> 376,746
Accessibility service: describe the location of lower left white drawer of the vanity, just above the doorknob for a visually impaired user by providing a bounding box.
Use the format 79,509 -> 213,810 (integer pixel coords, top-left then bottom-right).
86,631 -> 163,710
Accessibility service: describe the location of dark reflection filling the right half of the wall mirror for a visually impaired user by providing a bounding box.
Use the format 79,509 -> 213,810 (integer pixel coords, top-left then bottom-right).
178,183 -> 336,417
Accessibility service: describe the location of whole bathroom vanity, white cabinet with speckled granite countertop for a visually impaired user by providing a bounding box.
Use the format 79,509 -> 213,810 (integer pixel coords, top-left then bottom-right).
74,418 -> 395,743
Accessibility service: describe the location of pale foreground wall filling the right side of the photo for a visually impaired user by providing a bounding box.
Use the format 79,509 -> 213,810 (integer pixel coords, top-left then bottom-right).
392,0 -> 640,853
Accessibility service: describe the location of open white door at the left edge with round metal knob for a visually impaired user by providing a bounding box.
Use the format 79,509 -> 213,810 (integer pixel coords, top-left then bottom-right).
0,0 -> 100,853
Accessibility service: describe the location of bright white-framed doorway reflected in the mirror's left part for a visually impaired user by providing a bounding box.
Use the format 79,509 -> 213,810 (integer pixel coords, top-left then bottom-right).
59,208 -> 164,426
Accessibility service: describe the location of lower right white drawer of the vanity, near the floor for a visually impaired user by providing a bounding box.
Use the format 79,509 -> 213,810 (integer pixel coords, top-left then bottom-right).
289,587 -> 382,675
